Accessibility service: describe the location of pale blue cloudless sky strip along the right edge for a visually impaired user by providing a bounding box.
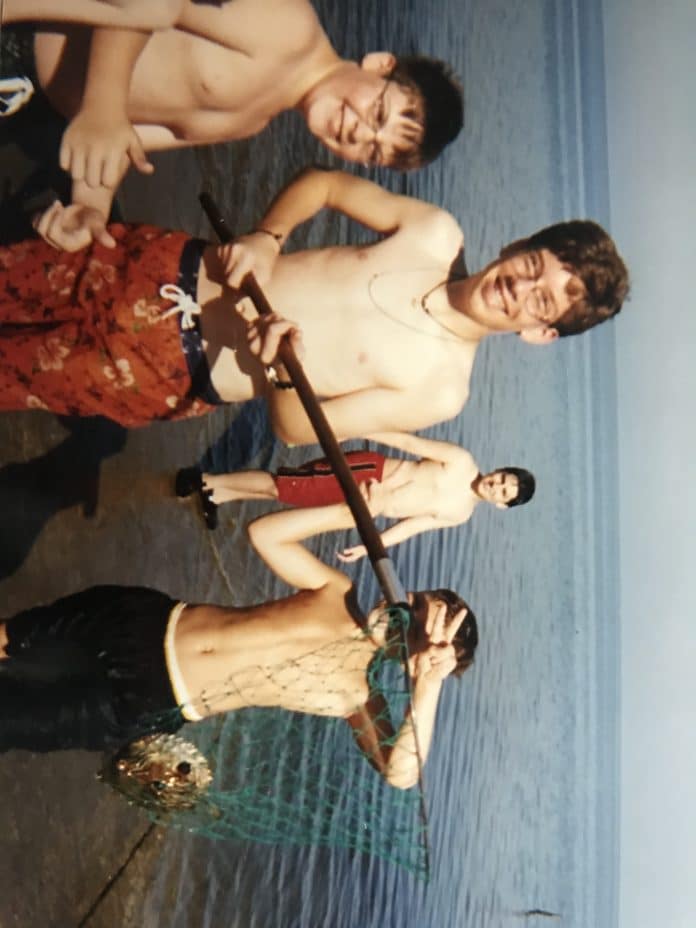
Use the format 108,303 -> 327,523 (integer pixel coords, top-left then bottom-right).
604,0 -> 696,928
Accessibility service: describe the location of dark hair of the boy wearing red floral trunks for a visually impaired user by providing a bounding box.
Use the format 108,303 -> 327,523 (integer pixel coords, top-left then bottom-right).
501,219 -> 629,336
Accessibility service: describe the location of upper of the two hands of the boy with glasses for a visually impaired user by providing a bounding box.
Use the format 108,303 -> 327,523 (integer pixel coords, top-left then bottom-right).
60,109 -> 155,190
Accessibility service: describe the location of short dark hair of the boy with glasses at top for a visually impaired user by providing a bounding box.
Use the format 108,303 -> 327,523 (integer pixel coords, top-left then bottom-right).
388,55 -> 464,171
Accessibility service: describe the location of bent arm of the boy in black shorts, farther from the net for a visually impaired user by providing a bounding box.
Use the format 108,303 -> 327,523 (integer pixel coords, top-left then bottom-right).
248,506 -> 352,591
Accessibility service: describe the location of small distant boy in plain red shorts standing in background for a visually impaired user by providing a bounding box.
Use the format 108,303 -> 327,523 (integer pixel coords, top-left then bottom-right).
176,432 -> 535,540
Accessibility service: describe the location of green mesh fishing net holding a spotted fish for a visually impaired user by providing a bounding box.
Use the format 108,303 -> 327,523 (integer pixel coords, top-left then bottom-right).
101,607 -> 428,878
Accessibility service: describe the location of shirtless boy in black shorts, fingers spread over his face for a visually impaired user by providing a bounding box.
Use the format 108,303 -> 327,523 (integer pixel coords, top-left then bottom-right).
0,500 -> 478,789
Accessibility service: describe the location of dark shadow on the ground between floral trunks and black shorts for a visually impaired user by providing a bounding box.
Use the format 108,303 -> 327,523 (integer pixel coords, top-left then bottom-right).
0,417 -> 127,579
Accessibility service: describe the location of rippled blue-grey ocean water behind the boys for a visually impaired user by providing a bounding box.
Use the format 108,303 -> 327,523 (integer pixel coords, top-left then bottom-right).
144,0 -> 620,928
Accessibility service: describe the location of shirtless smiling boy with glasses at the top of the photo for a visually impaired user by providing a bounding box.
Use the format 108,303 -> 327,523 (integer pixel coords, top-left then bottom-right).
0,0 -> 462,243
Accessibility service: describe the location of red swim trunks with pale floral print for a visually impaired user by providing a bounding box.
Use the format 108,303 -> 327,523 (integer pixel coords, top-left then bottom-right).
0,224 -> 213,426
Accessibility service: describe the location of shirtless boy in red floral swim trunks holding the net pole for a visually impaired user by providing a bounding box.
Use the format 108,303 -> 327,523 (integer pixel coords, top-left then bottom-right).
0,170 -> 628,432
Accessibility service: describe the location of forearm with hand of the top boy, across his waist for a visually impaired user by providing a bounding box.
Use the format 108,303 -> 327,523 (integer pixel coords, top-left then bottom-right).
60,29 -> 154,190
